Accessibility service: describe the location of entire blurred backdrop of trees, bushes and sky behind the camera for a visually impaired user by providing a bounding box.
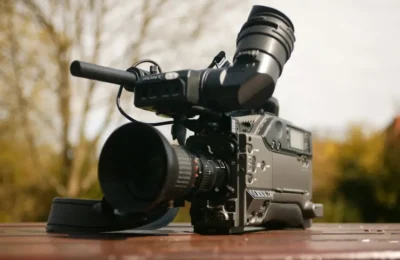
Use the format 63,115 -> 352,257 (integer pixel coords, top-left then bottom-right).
0,0 -> 400,222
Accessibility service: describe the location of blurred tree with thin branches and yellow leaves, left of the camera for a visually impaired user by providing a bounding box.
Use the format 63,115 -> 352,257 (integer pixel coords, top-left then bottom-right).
0,0 -> 231,221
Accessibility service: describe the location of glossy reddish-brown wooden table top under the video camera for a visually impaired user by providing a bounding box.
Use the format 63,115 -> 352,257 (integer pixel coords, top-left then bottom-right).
0,224 -> 400,260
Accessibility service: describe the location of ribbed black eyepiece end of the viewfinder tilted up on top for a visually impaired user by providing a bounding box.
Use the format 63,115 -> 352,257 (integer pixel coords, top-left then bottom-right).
235,5 -> 295,75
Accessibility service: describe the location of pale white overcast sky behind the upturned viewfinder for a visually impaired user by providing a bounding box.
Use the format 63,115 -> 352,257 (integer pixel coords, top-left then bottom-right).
83,0 -> 400,142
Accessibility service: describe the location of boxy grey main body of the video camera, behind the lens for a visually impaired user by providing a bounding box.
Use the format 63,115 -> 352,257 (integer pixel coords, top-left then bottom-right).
180,112 -> 323,234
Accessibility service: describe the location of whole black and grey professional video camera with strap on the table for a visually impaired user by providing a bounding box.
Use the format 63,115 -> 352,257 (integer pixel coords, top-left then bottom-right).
47,6 -> 323,234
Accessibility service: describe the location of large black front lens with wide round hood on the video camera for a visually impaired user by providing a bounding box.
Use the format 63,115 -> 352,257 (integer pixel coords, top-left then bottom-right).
98,122 -> 229,213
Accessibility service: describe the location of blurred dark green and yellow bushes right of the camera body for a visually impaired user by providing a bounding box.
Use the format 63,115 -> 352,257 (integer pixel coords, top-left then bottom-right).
314,126 -> 400,222
